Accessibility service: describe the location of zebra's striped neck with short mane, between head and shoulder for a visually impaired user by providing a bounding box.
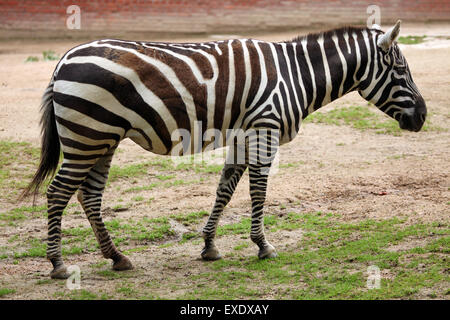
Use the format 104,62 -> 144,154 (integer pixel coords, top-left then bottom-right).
292,28 -> 376,118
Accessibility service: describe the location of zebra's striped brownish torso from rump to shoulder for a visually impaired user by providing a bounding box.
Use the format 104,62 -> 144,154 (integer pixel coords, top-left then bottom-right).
54,39 -> 290,154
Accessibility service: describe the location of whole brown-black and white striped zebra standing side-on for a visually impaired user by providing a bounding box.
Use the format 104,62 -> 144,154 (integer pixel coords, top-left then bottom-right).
23,20 -> 427,278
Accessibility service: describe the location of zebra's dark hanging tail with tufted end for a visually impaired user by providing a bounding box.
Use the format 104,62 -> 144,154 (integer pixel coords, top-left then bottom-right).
19,77 -> 61,204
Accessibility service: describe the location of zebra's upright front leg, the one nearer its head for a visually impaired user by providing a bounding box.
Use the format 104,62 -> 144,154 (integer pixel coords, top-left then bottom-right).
249,164 -> 277,259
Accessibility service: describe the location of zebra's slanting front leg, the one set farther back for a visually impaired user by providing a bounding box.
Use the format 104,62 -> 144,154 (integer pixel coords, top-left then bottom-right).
201,159 -> 247,260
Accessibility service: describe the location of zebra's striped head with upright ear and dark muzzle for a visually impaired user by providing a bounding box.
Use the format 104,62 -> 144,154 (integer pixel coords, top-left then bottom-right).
358,20 -> 427,132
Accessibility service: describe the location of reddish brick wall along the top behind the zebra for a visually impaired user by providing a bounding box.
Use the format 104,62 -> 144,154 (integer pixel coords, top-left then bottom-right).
0,0 -> 450,36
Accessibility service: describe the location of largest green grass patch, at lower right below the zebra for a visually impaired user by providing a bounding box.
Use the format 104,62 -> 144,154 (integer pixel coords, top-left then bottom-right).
180,212 -> 450,299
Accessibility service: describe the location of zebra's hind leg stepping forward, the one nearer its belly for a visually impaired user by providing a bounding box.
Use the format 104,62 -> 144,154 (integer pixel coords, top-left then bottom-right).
77,148 -> 133,271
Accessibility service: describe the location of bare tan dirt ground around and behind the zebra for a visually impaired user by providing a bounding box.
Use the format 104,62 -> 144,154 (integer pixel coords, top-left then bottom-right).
0,25 -> 450,299
